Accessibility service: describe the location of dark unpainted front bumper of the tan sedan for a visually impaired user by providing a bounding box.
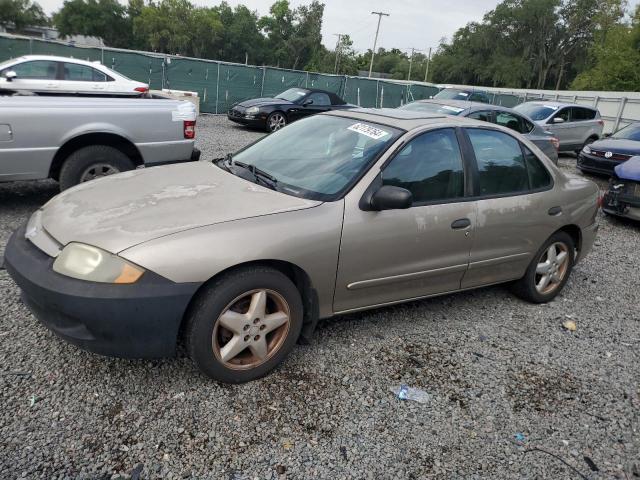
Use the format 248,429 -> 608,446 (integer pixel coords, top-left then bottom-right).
5,226 -> 200,358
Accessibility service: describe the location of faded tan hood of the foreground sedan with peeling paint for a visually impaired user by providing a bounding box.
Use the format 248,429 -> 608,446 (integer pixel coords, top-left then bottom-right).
42,162 -> 321,253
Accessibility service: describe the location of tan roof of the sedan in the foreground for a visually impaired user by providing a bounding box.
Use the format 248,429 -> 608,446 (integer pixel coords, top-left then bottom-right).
321,108 -> 493,131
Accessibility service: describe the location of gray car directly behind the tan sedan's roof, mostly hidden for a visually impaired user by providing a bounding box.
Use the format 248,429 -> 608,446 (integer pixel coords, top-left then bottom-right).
399,98 -> 559,165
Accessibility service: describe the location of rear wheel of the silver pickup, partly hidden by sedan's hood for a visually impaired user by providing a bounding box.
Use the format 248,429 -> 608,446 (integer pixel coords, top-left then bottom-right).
60,145 -> 135,190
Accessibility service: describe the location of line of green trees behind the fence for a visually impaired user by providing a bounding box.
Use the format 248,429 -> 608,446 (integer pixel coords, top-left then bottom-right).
0,0 -> 640,91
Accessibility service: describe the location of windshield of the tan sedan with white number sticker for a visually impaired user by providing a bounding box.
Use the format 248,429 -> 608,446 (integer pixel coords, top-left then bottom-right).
232,115 -> 402,201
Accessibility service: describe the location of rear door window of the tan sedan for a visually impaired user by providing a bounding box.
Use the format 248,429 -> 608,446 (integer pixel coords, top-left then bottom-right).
466,128 -> 529,196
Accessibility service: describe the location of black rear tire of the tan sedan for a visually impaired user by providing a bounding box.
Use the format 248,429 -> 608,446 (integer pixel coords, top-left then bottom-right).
511,231 -> 575,303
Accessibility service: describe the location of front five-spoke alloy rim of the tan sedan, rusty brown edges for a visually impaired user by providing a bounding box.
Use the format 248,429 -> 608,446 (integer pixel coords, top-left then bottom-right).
211,289 -> 291,370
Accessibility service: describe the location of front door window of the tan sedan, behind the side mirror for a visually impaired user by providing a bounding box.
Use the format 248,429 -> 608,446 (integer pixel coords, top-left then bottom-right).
382,128 -> 464,205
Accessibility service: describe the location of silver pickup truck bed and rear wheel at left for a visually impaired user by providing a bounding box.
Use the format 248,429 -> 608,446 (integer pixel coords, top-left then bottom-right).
0,96 -> 200,190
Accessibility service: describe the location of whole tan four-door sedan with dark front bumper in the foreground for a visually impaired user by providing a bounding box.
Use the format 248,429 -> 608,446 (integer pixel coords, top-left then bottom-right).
5,109 -> 598,382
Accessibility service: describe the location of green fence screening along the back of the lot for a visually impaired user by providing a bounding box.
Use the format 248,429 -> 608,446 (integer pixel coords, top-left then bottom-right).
0,35 -> 450,113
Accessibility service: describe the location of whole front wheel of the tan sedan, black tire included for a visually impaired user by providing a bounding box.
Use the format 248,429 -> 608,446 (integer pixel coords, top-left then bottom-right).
184,267 -> 303,383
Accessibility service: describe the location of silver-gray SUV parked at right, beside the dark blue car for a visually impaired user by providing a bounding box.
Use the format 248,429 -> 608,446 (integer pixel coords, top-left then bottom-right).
514,101 -> 604,153
